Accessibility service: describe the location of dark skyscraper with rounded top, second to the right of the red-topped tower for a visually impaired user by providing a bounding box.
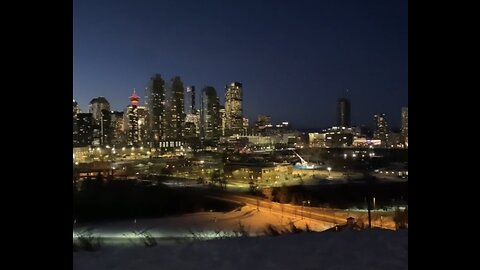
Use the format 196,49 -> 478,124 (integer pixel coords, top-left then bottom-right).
166,76 -> 185,141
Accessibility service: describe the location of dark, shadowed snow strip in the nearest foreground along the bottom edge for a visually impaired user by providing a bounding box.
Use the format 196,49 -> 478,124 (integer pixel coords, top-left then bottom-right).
73,229 -> 408,270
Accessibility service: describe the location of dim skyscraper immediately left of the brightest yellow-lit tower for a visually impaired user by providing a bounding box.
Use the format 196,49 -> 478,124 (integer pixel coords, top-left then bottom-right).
200,86 -> 220,142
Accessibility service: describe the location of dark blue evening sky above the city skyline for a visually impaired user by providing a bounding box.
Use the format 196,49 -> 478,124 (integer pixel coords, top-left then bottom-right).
73,0 -> 408,128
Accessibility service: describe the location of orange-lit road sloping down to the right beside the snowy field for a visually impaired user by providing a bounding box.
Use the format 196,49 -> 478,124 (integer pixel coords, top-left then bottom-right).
208,193 -> 395,229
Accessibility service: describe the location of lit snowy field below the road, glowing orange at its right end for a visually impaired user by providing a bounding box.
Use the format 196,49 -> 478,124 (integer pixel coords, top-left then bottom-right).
73,205 -> 335,245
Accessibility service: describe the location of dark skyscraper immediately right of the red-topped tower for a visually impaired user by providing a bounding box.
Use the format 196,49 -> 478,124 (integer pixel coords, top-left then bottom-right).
145,74 -> 166,147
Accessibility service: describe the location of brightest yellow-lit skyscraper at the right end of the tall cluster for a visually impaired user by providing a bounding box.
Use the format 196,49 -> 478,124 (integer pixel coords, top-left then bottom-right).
225,82 -> 243,136
